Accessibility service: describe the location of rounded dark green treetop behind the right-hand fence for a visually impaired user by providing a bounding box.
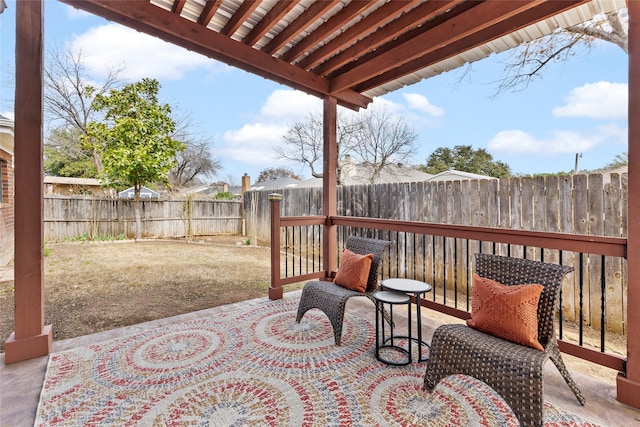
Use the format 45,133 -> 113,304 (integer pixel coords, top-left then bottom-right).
418,145 -> 511,178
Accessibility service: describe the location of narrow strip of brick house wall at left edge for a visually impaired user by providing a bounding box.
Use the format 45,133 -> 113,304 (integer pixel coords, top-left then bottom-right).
0,150 -> 15,267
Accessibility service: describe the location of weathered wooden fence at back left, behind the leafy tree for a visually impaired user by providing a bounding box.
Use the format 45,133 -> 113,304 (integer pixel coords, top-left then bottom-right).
44,196 -> 242,242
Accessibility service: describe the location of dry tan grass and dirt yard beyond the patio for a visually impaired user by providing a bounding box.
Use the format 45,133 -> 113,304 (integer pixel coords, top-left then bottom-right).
0,236 -> 297,352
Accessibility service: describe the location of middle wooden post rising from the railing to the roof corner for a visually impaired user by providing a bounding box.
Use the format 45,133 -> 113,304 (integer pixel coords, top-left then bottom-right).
322,96 -> 338,275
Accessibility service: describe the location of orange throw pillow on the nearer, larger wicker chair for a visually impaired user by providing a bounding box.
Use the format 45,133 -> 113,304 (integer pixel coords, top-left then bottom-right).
467,274 -> 544,350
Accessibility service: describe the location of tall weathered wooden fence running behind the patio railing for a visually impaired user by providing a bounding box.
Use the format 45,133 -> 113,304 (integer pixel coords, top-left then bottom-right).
245,174 -> 627,333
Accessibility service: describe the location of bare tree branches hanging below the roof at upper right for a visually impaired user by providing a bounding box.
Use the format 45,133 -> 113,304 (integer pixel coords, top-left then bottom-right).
496,9 -> 629,95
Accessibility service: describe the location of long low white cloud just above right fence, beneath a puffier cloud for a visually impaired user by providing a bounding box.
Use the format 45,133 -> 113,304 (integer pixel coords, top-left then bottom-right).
487,125 -> 627,155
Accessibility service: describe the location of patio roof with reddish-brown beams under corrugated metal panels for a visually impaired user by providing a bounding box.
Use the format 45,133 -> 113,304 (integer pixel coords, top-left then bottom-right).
67,0 -> 626,109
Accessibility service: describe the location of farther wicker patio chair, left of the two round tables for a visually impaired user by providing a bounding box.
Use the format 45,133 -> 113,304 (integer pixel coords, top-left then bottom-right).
296,236 -> 391,345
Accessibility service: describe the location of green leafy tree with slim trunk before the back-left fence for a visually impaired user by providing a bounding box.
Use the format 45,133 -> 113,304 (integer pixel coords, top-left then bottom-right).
83,79 -> 184,239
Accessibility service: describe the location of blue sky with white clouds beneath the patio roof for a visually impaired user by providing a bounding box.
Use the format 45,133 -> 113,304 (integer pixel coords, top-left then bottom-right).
0,0 -> 628,186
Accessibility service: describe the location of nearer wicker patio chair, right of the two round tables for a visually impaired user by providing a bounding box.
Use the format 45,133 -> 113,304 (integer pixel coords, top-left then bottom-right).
424,254 -> 585,426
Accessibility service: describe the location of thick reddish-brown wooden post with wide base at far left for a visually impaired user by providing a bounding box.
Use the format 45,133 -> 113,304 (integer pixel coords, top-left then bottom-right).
5,0 -> 52,363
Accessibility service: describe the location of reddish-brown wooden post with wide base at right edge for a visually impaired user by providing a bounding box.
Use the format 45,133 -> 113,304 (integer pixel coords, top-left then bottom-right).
616,1 -> 640,408
